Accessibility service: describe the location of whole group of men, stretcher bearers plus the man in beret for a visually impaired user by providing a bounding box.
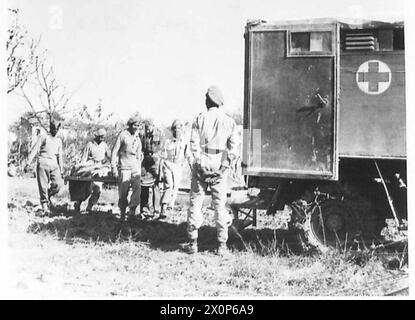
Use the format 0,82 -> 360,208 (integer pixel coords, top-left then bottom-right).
28,86 -> 237,254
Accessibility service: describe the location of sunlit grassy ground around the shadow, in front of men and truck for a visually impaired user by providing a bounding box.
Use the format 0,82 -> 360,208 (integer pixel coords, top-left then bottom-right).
8,178 -> 408,298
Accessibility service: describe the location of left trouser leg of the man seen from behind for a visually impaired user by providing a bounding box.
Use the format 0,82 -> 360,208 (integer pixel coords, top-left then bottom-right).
187,174 -> 207,240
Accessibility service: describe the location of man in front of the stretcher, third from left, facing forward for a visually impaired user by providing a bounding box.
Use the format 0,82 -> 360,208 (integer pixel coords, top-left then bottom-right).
111,117 -> 142,220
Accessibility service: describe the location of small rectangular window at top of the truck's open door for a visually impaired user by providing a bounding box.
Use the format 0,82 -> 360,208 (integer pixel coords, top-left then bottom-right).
289,31 -> 332,56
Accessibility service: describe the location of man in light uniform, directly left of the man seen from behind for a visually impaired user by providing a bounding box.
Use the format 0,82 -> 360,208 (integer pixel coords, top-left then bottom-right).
160,119 -> 191,218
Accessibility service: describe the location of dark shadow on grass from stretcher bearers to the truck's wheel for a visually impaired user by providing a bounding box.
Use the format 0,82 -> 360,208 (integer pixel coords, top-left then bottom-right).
28,212 -> 302,254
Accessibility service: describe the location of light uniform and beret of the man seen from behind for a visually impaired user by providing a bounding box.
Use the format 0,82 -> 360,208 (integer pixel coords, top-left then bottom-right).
187,87 -> 236,250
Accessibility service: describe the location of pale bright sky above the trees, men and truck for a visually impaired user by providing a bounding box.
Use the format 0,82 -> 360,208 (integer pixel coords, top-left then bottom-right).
8,0 -> 404,124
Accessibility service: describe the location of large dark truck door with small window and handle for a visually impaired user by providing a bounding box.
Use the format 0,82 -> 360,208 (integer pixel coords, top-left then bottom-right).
243,23 -> 339,180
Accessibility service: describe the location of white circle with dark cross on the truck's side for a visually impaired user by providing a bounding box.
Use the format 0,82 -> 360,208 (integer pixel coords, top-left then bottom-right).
356,60 -> 392,94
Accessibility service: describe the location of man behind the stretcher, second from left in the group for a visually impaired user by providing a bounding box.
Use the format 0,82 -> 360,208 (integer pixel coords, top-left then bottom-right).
75,128 -> 111,213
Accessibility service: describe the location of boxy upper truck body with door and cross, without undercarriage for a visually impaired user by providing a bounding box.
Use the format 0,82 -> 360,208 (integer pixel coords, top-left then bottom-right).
243,20 -> 406,180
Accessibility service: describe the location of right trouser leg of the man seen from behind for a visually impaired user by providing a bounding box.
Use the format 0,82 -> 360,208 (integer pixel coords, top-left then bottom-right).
211,179 -> 232,243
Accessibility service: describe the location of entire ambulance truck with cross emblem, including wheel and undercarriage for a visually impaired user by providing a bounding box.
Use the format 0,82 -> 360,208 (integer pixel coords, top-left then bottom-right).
239,19 -> 407,247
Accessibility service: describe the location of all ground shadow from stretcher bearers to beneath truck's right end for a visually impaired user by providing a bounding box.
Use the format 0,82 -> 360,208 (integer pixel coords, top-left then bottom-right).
23,212 -> 408,269
